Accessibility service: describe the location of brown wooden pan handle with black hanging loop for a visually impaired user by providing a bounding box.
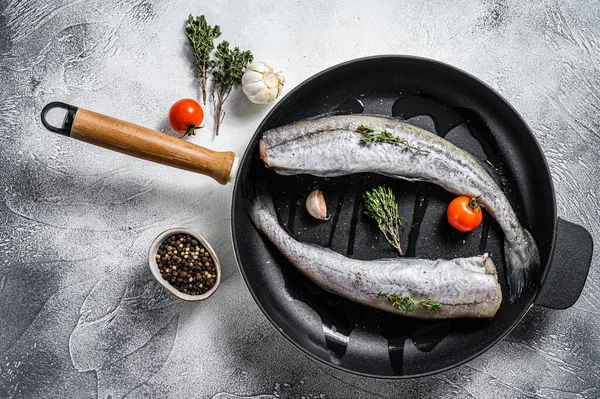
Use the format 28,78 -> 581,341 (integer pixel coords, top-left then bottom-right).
42,102 -> 239,184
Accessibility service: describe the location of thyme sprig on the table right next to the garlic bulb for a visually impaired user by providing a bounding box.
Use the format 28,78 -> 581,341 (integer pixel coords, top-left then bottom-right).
212,41 -> 254,136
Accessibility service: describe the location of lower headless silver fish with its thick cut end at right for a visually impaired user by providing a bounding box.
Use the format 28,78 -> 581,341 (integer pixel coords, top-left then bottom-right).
249,201 -> 502,319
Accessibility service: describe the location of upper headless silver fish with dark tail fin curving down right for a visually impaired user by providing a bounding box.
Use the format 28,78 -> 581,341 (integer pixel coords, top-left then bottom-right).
259,115 -> 540,303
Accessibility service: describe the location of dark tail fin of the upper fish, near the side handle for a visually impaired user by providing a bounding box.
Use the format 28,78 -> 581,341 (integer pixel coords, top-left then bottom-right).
504,229 -> 541,303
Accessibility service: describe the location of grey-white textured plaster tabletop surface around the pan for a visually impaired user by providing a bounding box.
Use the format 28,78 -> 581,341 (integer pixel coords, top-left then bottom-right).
0,0 -> 600,399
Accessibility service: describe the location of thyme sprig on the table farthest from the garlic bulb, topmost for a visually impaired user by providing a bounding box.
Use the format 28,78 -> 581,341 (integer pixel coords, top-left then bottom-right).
185,14 -> 221,105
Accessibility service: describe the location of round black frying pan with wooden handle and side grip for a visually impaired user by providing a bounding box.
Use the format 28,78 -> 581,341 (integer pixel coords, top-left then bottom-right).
42,56 -> 593,378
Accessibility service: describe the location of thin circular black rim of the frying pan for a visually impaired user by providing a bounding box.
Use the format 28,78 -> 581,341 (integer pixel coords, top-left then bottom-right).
230,54 -> 557,380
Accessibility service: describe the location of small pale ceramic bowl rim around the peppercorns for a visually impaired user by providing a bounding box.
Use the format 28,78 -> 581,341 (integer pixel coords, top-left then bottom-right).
148,228 -> 221,302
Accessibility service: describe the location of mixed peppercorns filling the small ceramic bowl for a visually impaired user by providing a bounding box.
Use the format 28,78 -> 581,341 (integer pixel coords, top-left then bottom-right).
156,234 -> 216,295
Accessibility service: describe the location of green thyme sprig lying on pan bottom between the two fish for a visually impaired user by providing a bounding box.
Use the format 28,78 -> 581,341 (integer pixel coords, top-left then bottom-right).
363,186 -> 402,255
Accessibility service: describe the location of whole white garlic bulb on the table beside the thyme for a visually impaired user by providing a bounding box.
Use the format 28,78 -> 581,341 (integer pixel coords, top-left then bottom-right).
242,62 -> 285,104
